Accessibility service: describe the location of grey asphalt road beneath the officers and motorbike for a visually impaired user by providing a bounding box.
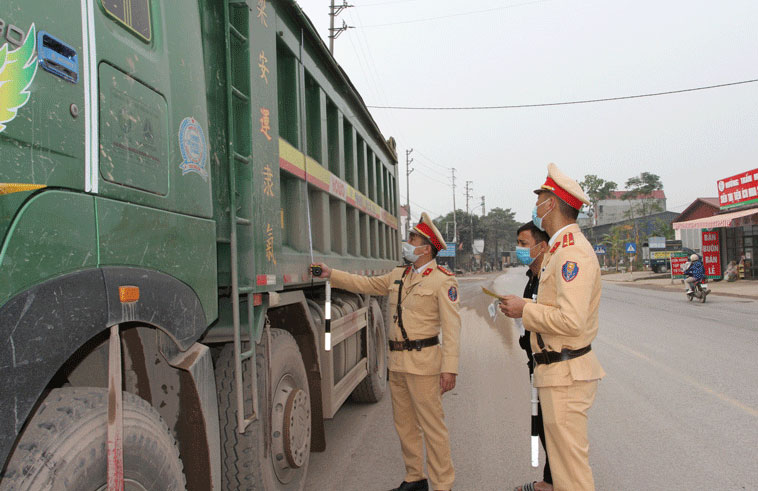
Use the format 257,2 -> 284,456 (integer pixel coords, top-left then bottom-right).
306,268 -> 758,491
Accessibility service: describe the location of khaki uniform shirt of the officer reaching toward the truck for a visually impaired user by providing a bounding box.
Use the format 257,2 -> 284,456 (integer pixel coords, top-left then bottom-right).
331,261 -> 461,375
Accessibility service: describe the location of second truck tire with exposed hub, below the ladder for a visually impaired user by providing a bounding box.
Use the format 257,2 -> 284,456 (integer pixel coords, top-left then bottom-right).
215,329 -> 311,491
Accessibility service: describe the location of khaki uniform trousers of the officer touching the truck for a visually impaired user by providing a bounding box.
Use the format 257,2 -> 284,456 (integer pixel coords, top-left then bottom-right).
389,371 -> 455,489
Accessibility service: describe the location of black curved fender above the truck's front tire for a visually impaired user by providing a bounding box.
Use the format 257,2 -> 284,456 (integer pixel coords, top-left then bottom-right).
0,267 -> 208,474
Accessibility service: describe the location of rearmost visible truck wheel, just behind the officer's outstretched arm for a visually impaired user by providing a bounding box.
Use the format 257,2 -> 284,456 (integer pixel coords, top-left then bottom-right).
352,298 -> 387,402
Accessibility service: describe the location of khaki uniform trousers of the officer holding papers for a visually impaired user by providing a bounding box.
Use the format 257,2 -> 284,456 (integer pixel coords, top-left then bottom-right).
539,380 -> 597,491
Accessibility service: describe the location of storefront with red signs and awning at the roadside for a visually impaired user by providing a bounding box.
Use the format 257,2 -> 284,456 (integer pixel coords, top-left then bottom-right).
672,169 -> 758,280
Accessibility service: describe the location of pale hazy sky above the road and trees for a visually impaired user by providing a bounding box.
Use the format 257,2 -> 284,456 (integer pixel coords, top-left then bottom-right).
292,0 -> 758,221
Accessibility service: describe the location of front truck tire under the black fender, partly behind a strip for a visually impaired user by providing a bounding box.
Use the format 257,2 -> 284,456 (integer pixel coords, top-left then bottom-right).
0,387 -> 186,491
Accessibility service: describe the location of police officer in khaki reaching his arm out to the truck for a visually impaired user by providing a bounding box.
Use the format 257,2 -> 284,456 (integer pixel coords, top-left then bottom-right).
310,213 -> 461,491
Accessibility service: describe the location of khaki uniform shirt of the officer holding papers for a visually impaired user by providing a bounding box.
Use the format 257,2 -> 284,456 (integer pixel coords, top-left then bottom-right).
523,224 -> 605,387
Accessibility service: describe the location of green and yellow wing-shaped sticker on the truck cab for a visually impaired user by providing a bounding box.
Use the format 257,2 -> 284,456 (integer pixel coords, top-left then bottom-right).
0,23 -> 38,133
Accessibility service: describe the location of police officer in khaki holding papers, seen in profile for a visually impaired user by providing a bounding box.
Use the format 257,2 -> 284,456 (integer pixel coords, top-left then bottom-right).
501,164 -> 605,491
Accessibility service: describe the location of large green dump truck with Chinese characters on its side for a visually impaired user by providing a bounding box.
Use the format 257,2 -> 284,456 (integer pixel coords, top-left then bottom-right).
0,0 -> 400,491
